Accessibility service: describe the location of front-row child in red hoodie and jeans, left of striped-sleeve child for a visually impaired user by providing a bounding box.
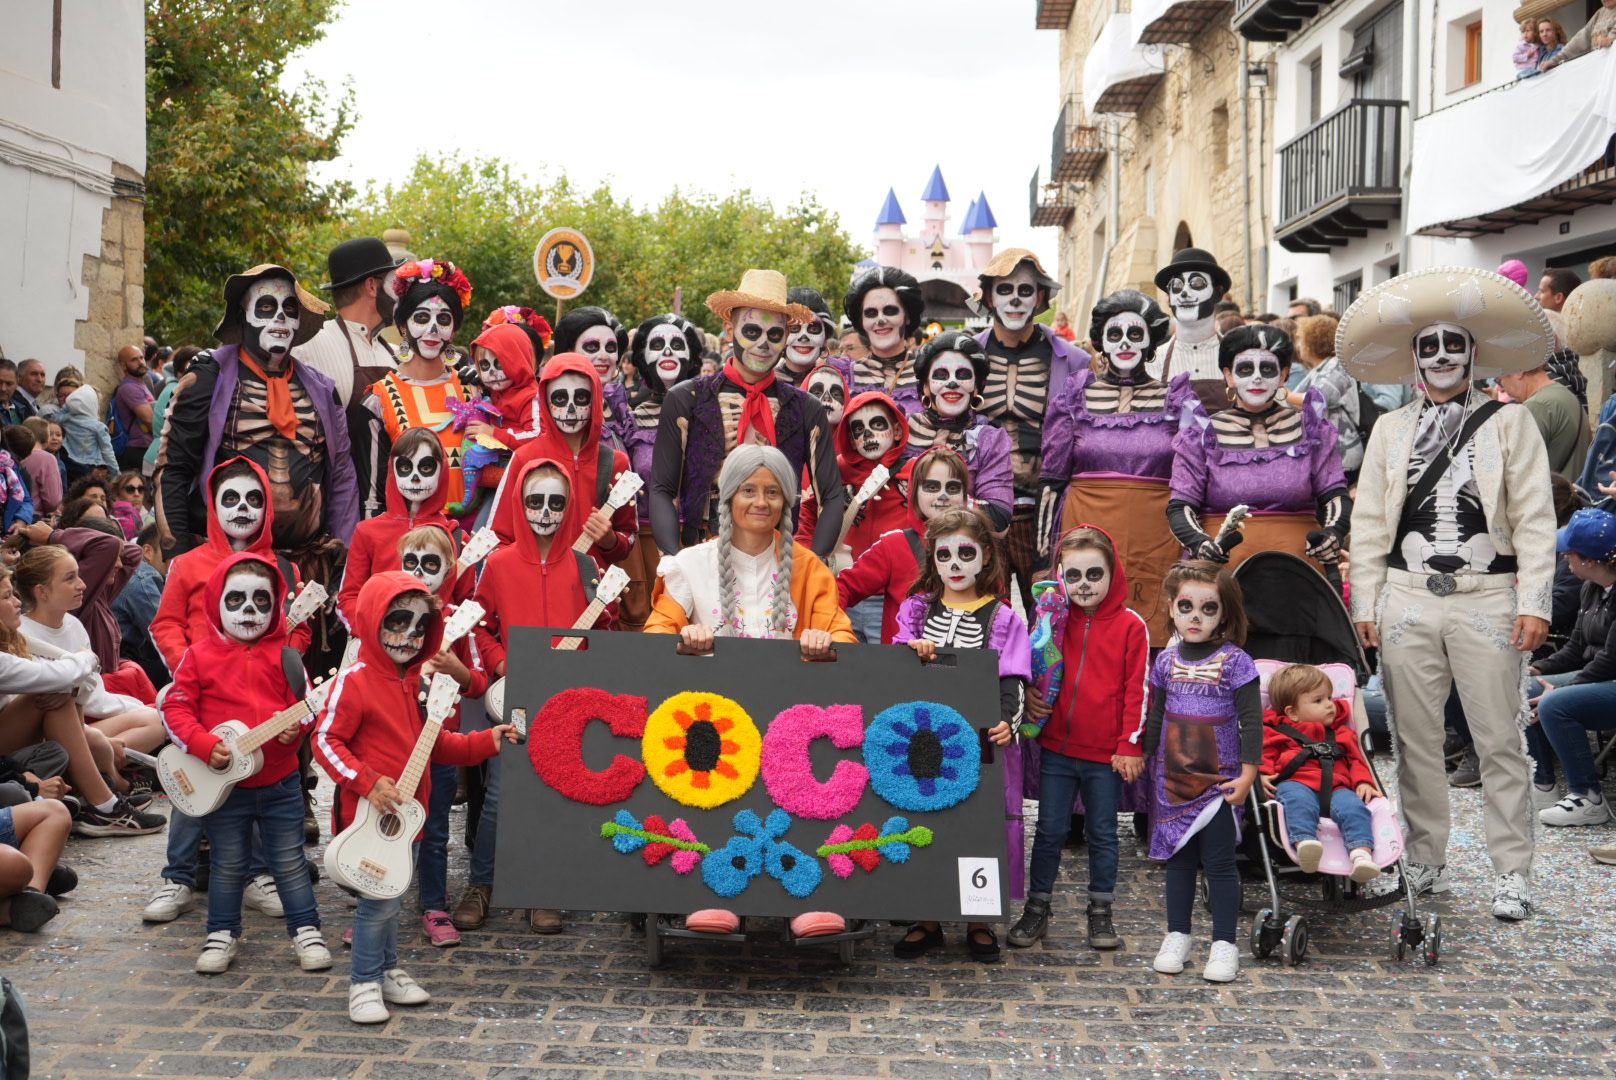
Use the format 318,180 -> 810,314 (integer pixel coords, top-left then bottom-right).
163,551 -> 331,975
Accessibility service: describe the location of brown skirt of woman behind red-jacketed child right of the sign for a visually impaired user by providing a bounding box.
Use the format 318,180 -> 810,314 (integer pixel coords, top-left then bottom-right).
1052,477 -> 1183,648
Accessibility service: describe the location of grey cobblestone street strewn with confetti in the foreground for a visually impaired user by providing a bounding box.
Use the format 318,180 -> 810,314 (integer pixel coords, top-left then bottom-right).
22,772 -> 1616,1080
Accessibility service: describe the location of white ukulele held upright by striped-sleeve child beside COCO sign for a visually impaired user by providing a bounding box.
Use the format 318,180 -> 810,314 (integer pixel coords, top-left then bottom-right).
325,671 -> 461,901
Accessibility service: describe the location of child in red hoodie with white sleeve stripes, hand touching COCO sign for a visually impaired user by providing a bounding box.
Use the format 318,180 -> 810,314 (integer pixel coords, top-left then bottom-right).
314,571 -> 516,1023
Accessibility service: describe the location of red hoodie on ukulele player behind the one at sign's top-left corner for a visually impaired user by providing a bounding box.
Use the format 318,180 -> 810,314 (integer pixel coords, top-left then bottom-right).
488,352 -> 640,563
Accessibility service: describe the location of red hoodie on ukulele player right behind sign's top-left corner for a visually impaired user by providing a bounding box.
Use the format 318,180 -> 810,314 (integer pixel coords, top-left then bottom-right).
473,458 -> 616,676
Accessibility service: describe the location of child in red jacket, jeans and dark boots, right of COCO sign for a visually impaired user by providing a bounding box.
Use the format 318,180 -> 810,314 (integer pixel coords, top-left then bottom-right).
1010,525 -> 1151,949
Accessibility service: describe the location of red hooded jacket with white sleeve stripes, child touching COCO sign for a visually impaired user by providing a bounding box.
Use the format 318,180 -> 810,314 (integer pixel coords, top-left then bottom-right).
314,571 -> 499,833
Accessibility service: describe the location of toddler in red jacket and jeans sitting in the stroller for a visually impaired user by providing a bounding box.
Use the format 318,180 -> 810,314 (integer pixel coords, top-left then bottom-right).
1262,664 -> 1380,883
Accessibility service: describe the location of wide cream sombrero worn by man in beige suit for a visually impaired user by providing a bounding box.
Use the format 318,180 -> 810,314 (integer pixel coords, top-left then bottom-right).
1335,267 -> 1555,383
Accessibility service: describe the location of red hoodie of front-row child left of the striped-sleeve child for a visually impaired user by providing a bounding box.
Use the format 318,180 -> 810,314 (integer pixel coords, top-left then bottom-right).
163,548 -> 314,787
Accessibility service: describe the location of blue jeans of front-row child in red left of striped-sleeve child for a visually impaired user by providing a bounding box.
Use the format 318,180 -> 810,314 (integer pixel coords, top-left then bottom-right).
202,770 -> 320,938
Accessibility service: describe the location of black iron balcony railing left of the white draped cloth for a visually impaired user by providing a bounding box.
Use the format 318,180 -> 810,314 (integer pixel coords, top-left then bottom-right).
1273,100 -> 1408,251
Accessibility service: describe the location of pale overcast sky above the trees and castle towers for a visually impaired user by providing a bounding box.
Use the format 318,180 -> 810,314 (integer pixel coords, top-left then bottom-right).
289,0 -> 1060,286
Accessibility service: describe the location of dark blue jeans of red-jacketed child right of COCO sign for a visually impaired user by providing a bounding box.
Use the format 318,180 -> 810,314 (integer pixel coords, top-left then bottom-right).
1026,750 -> 1122,902
